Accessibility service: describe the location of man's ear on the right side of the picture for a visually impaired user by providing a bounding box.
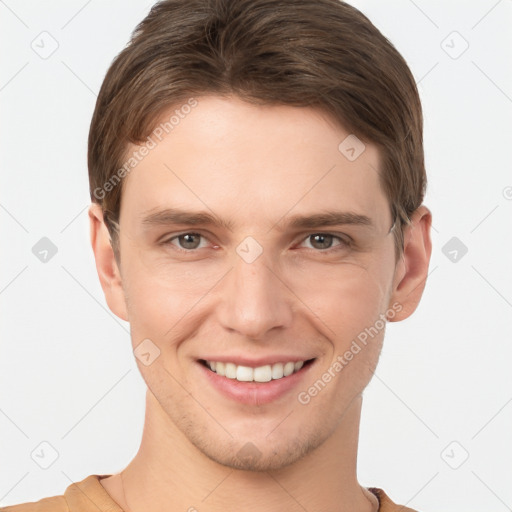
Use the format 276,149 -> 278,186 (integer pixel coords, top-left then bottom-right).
389,205 -> 432,322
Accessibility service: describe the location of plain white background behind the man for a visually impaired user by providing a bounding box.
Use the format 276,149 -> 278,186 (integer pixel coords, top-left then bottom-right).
0,0 -> 512,512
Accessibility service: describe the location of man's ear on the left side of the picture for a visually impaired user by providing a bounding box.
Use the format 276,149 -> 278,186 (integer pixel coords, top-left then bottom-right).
89,203 -> 128,321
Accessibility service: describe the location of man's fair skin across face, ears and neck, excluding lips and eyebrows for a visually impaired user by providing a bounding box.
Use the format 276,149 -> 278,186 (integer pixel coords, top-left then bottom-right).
89,96 -> 432,512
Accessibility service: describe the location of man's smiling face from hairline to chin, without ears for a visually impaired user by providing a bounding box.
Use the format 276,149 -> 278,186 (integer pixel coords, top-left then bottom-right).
102,96 -> 410,470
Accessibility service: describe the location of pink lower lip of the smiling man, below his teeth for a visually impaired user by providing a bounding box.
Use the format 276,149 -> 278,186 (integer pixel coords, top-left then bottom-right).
197,361 -> 315,405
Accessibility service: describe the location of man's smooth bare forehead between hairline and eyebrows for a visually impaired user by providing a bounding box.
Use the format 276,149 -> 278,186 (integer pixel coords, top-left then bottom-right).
121,96 -> 390,232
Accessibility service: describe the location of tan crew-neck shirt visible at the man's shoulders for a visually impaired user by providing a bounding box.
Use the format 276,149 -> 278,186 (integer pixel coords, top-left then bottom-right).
0,475 -> 416,512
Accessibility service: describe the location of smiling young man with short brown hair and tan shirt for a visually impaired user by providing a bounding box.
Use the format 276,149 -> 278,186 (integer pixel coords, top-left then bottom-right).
1,0 -> 431,512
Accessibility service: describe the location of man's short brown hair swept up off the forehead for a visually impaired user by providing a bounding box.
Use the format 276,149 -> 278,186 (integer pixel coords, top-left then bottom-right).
88,0 -> 426,257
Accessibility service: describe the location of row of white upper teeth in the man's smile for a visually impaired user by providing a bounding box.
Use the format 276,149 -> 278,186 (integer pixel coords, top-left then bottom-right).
206,361 -> 304,382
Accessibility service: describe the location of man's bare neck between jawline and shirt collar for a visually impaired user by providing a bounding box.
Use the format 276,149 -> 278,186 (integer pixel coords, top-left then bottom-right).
102,391 -> 378,512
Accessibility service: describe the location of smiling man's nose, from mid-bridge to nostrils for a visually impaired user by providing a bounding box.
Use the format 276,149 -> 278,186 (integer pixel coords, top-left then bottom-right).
217,249 -> 293,340
